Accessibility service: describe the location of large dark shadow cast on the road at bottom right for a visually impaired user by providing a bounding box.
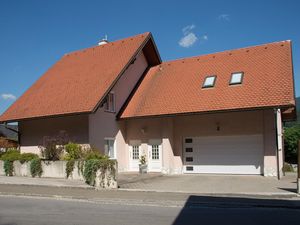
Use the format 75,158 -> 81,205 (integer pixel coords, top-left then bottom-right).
173,196 -> 300,225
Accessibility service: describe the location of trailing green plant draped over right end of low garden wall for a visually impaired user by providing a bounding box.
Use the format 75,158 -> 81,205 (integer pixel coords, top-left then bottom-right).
83,158 -> 116,186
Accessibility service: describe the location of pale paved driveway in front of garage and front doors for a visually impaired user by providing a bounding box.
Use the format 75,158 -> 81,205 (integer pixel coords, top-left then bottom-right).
118,173 -> 297,195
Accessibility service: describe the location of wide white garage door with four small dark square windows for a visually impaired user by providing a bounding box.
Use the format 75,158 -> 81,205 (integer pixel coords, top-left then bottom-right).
183,134 -> 263,174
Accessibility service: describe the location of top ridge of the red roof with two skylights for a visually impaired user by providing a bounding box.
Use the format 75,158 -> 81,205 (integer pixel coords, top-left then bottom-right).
160,40 -> 291,65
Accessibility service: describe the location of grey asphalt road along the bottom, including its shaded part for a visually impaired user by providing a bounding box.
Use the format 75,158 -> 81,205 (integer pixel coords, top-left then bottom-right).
0,195 -> 300,225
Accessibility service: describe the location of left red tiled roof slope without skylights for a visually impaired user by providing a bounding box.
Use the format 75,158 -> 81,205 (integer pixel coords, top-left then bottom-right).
0,33 -> 151,122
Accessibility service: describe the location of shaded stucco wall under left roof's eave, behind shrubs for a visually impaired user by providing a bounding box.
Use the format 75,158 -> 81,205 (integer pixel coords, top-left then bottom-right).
19,115 -> 89,154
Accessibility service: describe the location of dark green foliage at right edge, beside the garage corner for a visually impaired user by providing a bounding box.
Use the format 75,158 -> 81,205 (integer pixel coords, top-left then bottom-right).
284,124 -> 300,163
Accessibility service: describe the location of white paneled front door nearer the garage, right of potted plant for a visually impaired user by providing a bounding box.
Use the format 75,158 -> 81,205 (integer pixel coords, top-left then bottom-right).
148,140 -> 162,172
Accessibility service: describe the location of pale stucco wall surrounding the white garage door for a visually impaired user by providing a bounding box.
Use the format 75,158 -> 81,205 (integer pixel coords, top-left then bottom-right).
125,110 -> 277,176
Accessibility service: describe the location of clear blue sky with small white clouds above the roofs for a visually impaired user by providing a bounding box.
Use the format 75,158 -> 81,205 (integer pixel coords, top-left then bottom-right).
0,0 -> 300,113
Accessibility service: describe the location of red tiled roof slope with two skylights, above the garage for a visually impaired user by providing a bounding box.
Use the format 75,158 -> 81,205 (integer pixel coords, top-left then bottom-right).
120,41 -> 295,118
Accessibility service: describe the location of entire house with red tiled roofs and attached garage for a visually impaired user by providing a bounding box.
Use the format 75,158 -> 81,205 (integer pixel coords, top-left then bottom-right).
0,33 -> 296,176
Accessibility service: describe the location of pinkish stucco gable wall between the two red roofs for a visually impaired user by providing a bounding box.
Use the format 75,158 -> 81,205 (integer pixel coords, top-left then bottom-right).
89,52 -> 148,171
